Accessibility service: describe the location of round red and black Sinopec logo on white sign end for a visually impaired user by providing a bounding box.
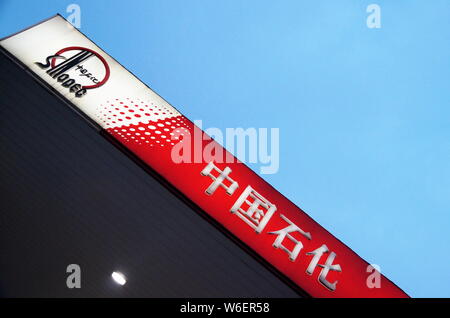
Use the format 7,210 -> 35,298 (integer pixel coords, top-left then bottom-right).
35,46 -> 110,97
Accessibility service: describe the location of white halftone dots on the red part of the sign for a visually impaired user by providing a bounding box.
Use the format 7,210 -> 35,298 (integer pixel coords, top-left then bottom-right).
107,116 -> 192,147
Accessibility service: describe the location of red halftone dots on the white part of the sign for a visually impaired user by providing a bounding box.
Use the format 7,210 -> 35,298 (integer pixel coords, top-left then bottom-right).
96,98 -> 181,128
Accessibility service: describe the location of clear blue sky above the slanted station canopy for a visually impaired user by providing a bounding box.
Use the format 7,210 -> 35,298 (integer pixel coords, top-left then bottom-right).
0,0 -> 450,297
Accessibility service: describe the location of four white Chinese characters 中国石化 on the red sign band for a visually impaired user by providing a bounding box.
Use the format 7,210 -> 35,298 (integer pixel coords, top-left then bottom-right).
200,161 -> 342,291
